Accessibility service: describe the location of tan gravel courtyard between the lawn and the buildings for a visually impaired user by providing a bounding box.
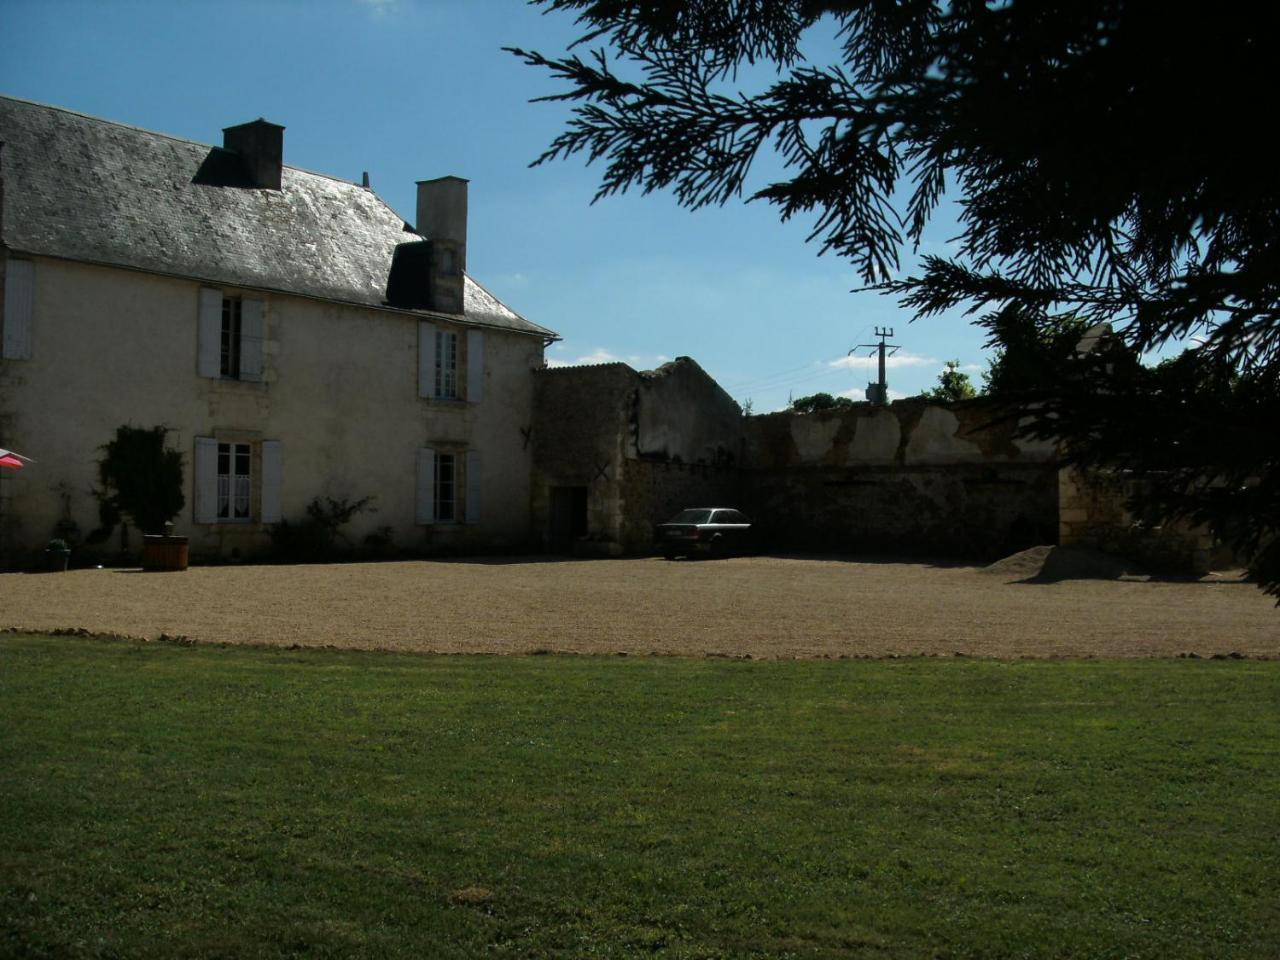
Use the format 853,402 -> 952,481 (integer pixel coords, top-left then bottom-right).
0,557 -> 1280,658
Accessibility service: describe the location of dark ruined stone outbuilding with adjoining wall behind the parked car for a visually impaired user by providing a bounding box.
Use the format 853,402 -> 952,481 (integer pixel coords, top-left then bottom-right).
531,357 -> 1059,557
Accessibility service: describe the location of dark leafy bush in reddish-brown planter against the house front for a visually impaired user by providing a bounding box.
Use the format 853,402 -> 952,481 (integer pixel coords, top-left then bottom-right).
95,426 -> 188,570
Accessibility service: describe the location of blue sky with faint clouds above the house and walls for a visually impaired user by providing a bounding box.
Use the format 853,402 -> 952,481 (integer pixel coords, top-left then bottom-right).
0,0 -> 986,412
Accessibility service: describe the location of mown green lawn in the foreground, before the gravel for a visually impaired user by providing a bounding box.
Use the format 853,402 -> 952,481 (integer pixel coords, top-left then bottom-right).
0,635 -> 1280,960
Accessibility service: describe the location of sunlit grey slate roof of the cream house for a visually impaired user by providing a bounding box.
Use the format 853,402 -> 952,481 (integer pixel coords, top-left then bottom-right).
0,96 -> 556,338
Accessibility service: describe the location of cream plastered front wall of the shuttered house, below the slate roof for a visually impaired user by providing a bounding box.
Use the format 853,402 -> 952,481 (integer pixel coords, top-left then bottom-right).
0,259 -> 541,559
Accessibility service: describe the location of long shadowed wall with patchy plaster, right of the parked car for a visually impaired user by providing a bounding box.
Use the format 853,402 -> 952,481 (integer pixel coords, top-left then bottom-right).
745,401 -> 1057,556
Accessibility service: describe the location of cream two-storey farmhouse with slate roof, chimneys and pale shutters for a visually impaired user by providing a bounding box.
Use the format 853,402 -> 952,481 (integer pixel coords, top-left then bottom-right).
0,97 -> 557,563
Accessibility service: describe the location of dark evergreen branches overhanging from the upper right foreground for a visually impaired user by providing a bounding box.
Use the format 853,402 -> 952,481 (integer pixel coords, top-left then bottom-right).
515,0 -> 1280,593
